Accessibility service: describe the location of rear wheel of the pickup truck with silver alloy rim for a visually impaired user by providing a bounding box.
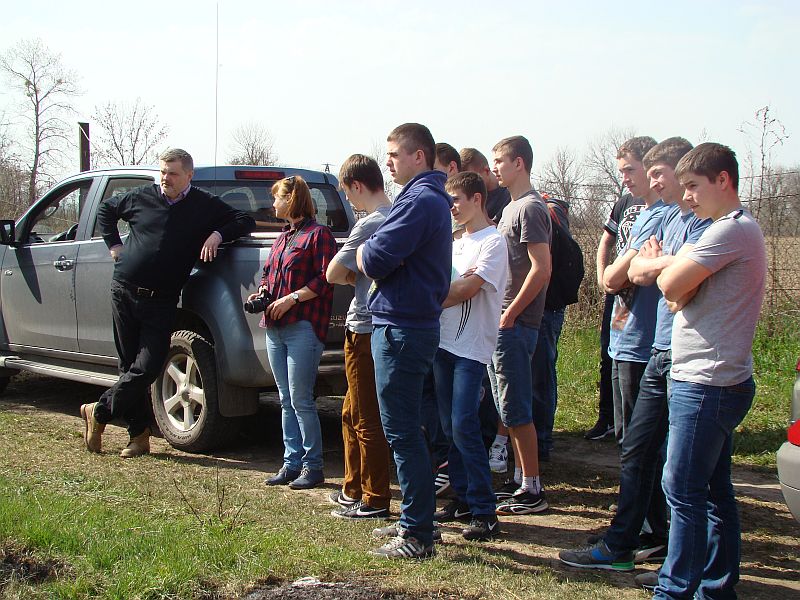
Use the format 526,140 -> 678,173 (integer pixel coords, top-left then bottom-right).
150,330 -> 239,452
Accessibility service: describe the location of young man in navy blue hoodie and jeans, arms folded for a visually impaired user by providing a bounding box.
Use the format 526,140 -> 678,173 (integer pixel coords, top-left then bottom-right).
357,123 -> 452,558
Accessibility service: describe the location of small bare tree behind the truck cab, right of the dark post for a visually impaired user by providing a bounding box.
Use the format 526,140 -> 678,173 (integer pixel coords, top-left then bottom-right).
92,98 -> 169,166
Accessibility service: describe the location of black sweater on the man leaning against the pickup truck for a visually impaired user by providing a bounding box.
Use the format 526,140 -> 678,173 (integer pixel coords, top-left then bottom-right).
97,184 -> 256,295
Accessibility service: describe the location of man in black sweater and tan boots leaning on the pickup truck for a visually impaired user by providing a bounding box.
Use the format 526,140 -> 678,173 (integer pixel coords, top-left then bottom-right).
81,148 -> 255,458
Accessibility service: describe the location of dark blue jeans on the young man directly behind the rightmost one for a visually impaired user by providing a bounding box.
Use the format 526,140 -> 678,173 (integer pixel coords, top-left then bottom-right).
603,350 -> 672,553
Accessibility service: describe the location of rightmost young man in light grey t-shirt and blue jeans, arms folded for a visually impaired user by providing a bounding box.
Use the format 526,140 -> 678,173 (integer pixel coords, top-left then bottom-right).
654,143 -> 767,598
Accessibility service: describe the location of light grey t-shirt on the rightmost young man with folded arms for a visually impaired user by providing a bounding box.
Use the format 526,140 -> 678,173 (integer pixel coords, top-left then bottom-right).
672,209 -> 767,387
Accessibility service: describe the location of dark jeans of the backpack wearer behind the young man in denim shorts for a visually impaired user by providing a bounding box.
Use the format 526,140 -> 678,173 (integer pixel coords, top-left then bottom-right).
531,308 -> 564,456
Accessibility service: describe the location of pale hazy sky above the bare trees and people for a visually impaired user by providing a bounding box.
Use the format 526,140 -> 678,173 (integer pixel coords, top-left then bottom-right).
0,0 -> 800,180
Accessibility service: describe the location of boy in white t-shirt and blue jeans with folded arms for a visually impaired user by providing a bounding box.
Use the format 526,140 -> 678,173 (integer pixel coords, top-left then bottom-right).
433,172 -> 508,540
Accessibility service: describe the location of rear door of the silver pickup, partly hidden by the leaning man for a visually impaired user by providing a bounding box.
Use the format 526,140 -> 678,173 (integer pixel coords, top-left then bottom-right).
75,173 -> 155,361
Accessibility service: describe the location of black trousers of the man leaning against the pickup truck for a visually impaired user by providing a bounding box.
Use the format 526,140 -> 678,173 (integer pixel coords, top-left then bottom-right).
94,280 -> 177,437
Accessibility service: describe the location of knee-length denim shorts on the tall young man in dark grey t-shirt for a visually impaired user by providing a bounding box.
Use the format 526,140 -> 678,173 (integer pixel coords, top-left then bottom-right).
489,323 -> 539,427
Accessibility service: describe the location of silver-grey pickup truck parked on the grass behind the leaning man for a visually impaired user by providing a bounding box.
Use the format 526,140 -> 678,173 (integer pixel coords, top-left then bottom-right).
0,166 -> 354,452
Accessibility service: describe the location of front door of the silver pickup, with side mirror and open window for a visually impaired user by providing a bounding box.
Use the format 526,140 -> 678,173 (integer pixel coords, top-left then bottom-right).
0,177 -> 94,354
